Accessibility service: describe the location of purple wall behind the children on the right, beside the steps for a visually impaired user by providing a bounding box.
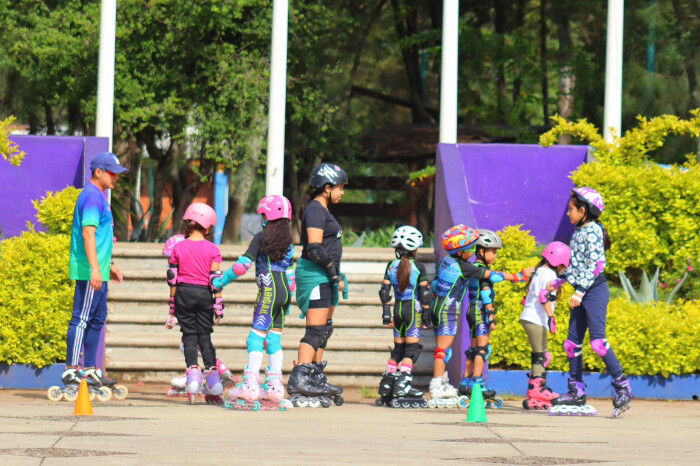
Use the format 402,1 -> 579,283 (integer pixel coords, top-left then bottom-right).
435,144 -> 588,384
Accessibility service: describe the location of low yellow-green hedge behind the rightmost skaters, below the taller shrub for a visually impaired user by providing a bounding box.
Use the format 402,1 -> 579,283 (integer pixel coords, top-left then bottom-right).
491,227 -> 700,377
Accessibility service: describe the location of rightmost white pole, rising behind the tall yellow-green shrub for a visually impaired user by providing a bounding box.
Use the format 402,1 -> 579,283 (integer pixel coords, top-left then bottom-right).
603,0 -> 625,142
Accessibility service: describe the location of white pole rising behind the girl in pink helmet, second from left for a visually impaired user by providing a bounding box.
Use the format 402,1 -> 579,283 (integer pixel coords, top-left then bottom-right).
265,0 -> 289,195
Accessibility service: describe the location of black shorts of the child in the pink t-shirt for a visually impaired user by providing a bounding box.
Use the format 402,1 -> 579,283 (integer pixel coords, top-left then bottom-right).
175,283 -> 214,335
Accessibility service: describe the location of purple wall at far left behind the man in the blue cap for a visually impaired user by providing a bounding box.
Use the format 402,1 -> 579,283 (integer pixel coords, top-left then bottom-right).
0,136 -> 109,238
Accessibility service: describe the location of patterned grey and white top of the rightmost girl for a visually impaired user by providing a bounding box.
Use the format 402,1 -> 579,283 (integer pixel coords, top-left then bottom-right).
564,222 -> 605,293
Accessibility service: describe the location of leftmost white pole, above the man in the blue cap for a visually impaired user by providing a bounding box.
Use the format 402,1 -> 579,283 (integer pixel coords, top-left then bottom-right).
95,0 -> 117,151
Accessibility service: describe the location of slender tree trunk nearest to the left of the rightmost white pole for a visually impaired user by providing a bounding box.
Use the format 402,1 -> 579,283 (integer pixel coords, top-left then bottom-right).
553,2 -> 576,144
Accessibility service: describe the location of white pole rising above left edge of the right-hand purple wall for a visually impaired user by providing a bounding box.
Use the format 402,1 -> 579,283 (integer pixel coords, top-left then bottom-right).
439,0 -> 459,144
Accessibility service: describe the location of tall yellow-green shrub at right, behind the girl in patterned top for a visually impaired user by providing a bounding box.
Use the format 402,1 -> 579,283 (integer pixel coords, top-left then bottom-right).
540,110 -> 700,281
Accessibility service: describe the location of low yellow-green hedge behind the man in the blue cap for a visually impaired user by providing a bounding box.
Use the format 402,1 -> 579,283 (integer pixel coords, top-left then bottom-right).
0,228 -> 73,367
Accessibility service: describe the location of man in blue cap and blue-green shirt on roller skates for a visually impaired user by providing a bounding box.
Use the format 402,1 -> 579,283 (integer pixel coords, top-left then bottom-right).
61,152 -> 127,385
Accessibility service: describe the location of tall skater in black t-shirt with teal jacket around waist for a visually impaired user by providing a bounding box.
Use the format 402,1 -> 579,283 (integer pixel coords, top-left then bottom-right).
287,163 -> 348,403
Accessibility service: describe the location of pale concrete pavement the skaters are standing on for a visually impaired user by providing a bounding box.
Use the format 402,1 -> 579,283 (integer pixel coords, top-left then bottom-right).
0,385 -> 700,465
